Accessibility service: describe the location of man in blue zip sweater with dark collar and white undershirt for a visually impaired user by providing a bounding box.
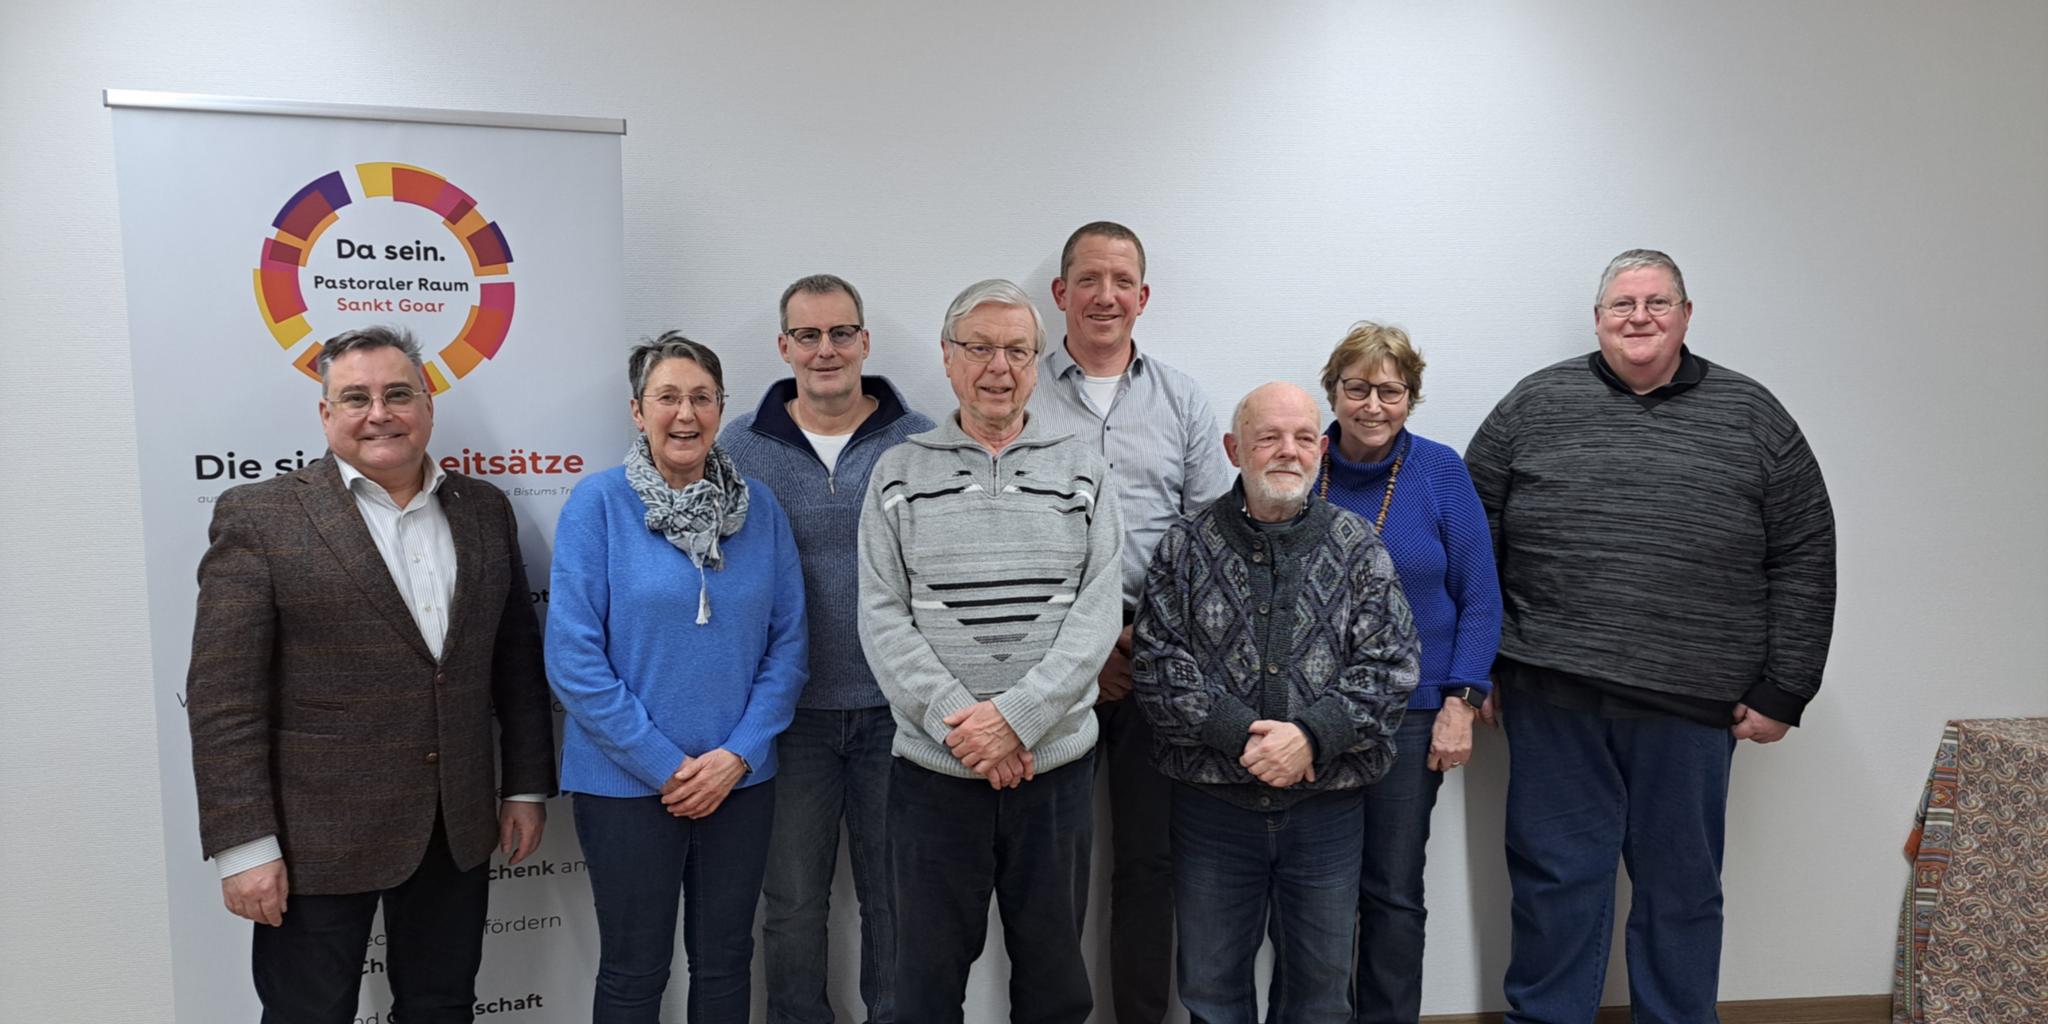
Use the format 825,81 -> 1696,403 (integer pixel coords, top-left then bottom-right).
719,274 -> 934,1024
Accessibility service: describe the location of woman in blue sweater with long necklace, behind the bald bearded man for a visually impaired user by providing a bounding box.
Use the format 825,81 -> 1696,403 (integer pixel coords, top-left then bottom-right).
1315,322 -> 1501,1024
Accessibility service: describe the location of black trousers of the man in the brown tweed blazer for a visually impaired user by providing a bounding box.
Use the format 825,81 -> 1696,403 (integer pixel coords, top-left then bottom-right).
250,819 -> 489,1024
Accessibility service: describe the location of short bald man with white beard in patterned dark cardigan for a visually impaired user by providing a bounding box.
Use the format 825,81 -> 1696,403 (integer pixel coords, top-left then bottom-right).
1133,383 -> 1417,1022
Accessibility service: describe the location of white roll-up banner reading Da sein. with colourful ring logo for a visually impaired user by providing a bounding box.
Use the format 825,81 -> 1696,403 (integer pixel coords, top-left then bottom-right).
104,90 -> 631,1024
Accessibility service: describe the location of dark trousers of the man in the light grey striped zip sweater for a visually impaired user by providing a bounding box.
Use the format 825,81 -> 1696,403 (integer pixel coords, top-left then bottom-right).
889,752 -> 1096,1024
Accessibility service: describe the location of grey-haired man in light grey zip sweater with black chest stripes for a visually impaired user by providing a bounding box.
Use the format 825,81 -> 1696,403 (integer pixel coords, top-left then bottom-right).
860,281 -> 1122,1024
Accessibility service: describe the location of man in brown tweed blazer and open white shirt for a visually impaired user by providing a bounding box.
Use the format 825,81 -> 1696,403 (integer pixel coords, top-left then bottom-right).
186,328 -> 555,1024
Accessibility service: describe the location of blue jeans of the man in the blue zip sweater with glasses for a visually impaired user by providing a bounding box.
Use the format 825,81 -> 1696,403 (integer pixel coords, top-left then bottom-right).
762,707 -> 895,1024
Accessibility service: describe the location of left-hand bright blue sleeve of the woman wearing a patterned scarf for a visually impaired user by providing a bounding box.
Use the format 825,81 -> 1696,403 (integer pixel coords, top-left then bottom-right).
545,477 -> 684,791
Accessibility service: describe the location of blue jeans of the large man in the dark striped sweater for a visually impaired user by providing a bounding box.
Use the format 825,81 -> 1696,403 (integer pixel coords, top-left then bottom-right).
1503,690 -> 1735,1024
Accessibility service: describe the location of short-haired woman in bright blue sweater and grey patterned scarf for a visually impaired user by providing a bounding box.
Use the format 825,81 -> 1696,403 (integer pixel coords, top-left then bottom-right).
547,332 -> 809,1024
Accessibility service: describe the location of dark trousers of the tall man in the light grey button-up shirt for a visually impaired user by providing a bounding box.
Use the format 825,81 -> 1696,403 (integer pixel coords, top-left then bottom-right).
1096,698 -> 1174,1024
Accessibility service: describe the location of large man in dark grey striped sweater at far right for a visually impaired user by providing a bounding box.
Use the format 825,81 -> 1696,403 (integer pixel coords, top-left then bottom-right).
1466,250 -> 1835,1024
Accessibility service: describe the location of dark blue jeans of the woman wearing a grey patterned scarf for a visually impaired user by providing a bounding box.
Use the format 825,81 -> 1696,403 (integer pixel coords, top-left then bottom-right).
575,780 -> 774,1024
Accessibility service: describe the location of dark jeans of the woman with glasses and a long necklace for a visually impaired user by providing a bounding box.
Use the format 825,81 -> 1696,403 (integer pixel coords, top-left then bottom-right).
1352,709 -> 1444,1024
